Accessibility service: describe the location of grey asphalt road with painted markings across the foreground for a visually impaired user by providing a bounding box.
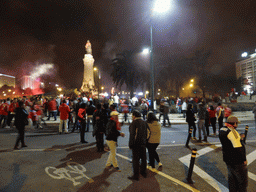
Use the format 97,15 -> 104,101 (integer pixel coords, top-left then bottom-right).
0,121 -> 256,192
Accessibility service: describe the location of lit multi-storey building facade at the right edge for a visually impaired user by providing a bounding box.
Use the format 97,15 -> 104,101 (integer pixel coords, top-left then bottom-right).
236,53 -> 256,93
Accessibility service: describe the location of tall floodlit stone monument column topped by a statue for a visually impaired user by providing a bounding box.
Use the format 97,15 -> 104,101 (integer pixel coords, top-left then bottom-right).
81,40 -> 98,95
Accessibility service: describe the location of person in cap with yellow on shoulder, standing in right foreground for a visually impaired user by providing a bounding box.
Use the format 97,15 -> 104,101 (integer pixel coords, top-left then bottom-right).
219,116 -> 248,192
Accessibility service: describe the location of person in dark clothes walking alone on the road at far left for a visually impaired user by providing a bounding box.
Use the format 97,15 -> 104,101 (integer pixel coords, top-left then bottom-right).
14,101 -> 28,150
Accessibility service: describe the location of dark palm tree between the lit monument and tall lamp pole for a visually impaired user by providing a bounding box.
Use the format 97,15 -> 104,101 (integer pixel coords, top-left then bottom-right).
110,50 -> 143,97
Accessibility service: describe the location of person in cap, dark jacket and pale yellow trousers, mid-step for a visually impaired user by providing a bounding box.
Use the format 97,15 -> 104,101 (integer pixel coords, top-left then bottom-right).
106,111 -> 125,171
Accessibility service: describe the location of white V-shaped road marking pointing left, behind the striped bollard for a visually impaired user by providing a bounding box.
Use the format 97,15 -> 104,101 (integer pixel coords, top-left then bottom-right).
179,145 -> 228,191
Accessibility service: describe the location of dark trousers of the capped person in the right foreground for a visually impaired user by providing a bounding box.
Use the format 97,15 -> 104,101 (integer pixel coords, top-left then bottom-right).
227,164 -> 248,192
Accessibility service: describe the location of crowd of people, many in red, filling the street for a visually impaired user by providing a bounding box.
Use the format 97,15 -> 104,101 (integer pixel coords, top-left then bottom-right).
0,96 -> 248,190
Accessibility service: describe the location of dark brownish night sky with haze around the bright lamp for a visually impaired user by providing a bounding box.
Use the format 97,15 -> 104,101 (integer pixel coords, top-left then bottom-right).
0,0 -> 256,91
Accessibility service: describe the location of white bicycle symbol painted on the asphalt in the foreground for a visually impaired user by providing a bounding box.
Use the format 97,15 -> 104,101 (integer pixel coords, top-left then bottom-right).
45,162 -> 94,186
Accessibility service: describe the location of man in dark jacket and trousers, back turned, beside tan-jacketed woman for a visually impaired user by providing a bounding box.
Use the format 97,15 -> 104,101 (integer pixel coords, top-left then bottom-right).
128,110 -> 149,181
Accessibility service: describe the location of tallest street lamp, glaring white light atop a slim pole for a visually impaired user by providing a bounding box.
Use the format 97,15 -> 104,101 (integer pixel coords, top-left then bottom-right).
150,0 -> 171,111
